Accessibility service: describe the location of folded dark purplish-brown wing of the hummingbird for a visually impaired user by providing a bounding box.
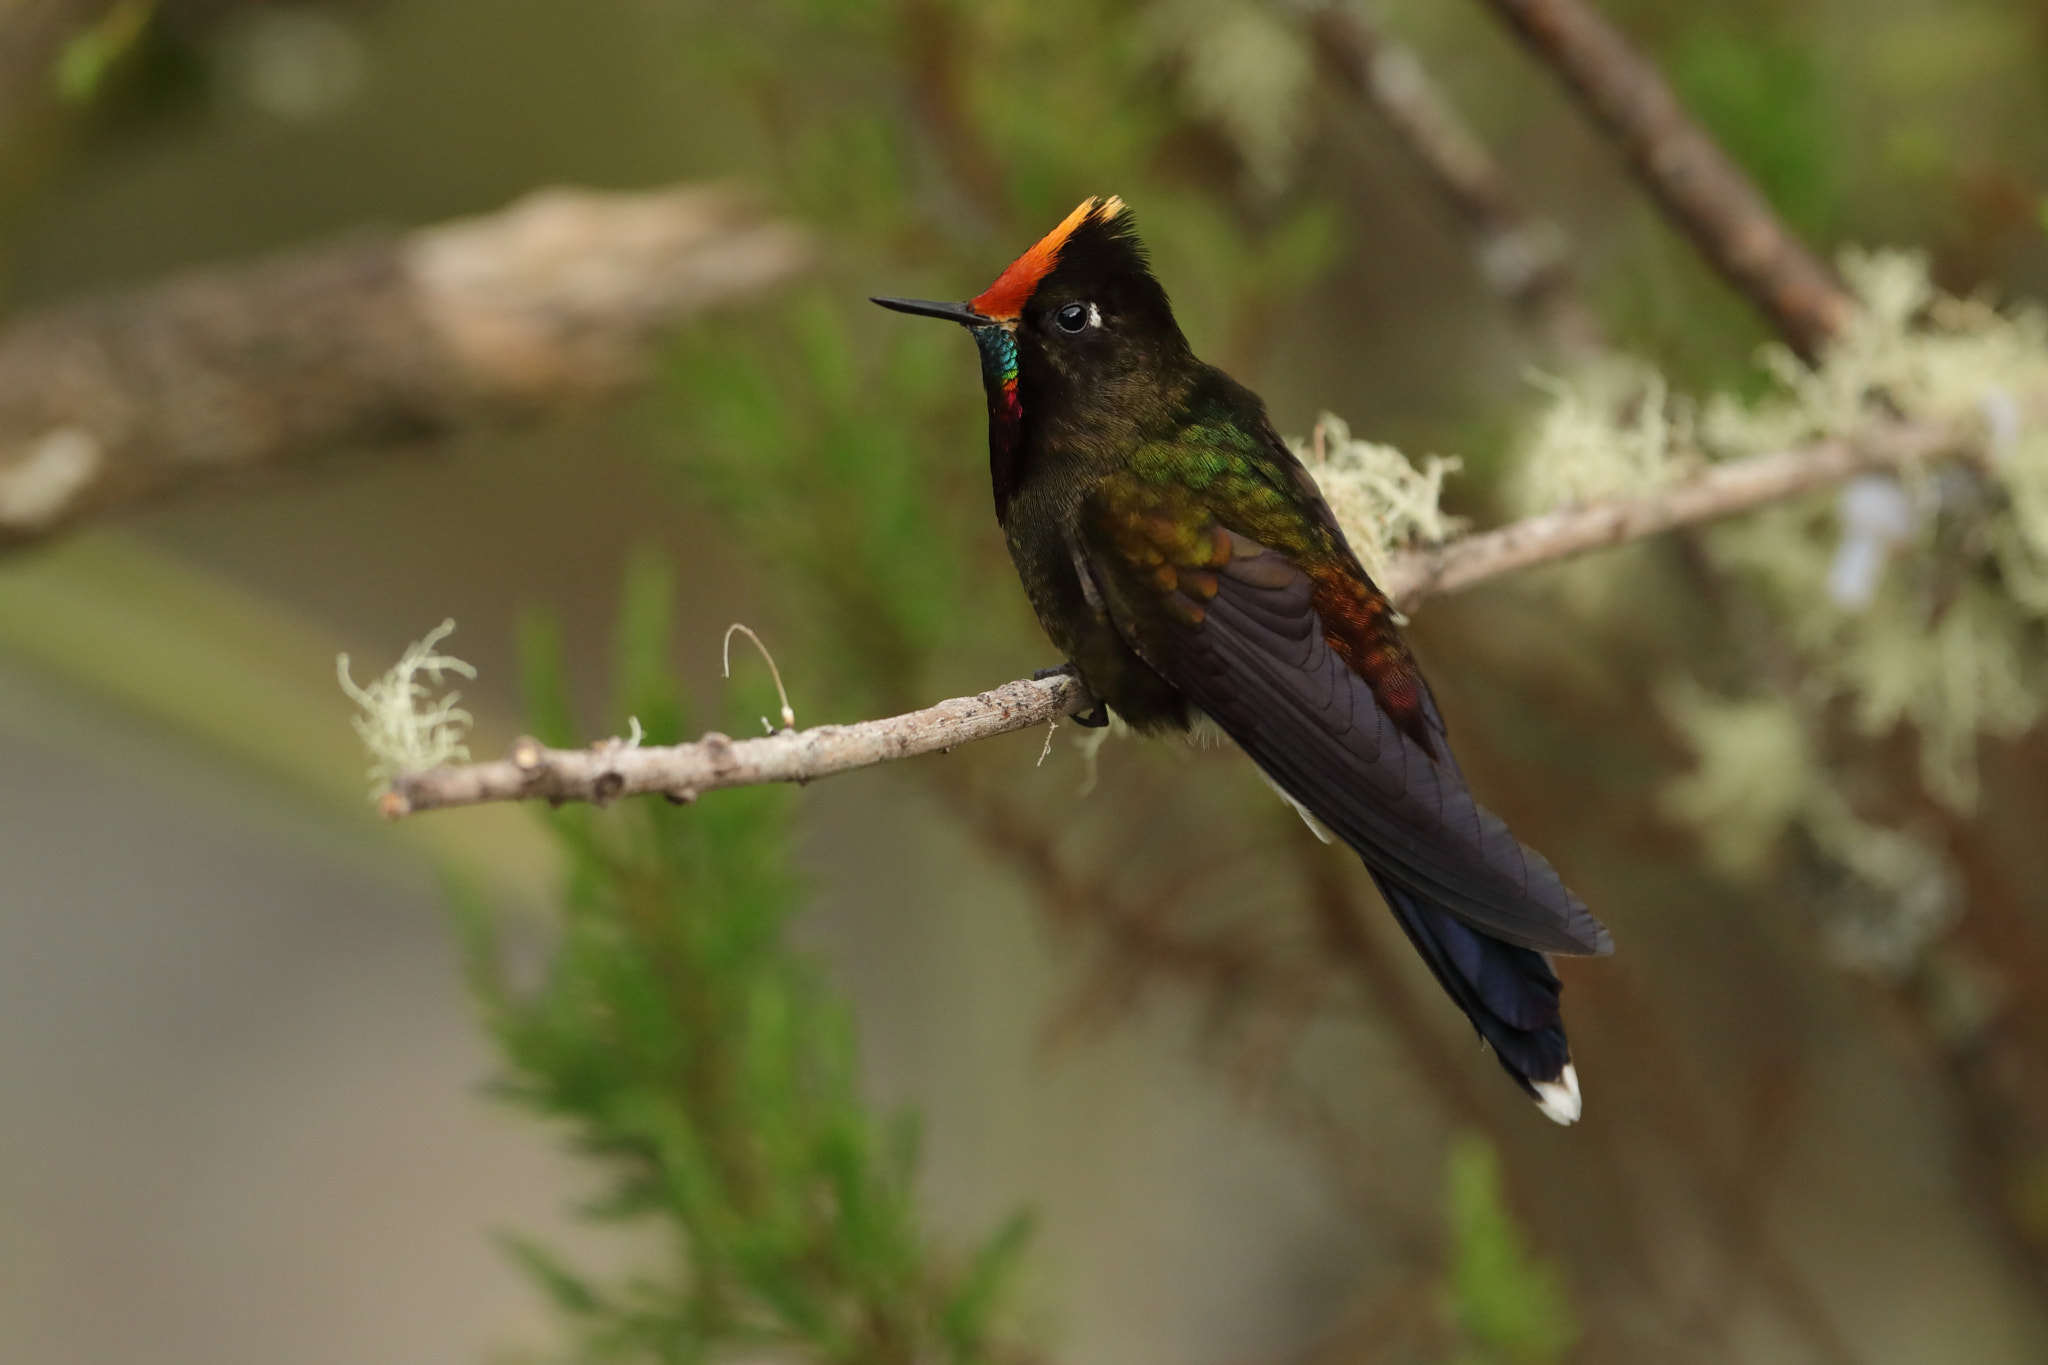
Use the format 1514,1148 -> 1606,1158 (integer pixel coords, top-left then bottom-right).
1079,501 -> 1612,966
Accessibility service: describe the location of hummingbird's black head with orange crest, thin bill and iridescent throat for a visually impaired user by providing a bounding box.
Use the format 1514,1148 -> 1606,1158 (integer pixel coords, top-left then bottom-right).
874,196 -> 1194,520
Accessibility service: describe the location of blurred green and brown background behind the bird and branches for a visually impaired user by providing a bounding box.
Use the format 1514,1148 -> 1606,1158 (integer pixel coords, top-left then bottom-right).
12,0 -> 2048,1365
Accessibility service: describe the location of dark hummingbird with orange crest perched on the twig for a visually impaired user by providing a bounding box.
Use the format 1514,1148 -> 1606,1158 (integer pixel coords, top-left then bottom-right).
874,196 -> 1612,1124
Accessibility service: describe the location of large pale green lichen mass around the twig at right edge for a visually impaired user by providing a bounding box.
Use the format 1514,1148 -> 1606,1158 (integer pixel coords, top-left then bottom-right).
1511,252 -> 2048,974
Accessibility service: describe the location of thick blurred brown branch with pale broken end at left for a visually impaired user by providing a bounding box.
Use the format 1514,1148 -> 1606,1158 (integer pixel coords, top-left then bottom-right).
0,188 -> 809,548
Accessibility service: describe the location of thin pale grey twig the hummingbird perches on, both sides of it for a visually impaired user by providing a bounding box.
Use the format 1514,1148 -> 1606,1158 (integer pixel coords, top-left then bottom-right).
381,424 -> 1980,819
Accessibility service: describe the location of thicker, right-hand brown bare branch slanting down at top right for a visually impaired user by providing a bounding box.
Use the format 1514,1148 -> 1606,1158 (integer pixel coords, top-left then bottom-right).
1487,0 -> 1855,360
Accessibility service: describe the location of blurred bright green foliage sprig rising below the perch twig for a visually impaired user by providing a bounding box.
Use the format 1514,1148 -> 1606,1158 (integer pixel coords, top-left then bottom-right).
463,548 -> 1026,1365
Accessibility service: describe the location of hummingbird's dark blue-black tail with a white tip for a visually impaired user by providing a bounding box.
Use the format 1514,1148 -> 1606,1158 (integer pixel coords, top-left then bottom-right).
1368,868 -> 1579,1124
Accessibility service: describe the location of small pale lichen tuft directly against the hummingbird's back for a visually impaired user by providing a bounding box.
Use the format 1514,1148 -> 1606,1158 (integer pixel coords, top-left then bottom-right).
1288,413 -> 1464,579
